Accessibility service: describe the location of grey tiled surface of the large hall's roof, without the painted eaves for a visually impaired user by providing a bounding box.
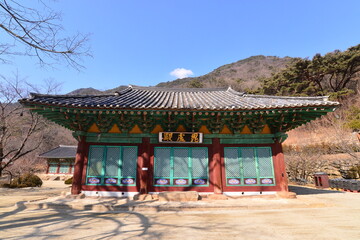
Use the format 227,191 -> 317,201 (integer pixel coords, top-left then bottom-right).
20,86 -> 339,110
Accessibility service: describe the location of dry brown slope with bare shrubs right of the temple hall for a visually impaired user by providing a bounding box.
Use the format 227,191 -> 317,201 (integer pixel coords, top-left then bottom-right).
284,98 -> 360,180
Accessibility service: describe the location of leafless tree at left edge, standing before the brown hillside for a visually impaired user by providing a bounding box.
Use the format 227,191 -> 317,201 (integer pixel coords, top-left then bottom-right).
0,75 -> 58,176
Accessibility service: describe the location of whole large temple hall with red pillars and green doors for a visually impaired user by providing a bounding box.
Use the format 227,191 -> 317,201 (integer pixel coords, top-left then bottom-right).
20,86 -> 339,196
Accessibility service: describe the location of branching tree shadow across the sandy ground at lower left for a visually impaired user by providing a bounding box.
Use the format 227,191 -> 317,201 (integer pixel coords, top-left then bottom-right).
0,197 -> 207,240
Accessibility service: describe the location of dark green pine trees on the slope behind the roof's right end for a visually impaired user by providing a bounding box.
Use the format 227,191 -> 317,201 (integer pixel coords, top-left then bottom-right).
257,44 -> 360,100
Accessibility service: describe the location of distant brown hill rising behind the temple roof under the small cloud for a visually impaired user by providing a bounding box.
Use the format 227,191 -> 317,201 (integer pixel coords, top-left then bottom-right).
156,55 -> 293,91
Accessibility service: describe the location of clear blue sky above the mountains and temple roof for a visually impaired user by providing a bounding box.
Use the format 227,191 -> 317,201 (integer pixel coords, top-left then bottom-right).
0,0 -> 360,93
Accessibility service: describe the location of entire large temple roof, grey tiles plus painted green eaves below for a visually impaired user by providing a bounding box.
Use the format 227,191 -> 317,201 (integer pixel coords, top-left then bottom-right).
19,86 -> 339,134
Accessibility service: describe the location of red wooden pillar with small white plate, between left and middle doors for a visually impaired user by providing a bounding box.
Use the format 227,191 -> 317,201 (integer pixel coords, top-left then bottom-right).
137,137 -> 150,194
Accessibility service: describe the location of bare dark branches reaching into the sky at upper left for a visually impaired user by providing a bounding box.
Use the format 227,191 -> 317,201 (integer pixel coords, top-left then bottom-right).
0,0 -> 90,70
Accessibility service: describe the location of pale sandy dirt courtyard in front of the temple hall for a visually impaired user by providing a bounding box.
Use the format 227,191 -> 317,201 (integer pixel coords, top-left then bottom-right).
0,185 -> 360,240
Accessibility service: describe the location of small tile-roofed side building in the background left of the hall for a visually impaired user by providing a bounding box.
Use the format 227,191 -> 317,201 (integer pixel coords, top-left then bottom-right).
39,145 -> 77,175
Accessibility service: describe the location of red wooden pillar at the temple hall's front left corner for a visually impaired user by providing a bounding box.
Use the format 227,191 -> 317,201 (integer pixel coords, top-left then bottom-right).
71,136 -> 86,195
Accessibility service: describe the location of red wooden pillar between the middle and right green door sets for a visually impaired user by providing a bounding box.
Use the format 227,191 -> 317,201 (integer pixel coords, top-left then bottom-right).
210,138 -> 223,194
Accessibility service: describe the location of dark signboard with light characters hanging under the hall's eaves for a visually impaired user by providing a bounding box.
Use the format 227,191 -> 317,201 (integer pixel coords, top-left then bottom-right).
159,132 -> 203,143
